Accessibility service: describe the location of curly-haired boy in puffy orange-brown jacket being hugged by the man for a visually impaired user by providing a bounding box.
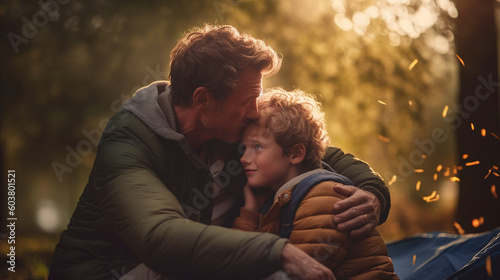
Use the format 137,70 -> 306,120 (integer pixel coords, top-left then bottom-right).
233,89 -> 398,279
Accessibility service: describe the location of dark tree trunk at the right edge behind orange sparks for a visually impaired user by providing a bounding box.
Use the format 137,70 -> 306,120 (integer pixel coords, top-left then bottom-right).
452,0 -> 500,233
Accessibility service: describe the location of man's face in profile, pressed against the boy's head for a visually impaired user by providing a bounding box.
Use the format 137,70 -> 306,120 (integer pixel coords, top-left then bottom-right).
202,69 -> 262,143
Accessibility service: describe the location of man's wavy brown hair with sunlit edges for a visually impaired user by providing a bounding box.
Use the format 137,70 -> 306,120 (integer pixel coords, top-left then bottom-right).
169,24 -> 281,107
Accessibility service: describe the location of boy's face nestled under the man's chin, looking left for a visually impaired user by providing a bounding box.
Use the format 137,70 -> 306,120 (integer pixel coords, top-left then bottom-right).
240,124 -> 295,191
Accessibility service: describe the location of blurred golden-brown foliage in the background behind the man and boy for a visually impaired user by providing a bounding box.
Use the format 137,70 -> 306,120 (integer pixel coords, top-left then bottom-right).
0,0 -> 476,279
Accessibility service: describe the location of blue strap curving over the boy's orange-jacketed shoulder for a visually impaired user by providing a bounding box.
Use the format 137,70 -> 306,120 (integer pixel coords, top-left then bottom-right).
280,170 -> 352,238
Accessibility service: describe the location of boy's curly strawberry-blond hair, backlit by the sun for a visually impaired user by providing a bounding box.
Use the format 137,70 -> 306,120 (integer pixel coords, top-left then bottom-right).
255,88 -> 330,170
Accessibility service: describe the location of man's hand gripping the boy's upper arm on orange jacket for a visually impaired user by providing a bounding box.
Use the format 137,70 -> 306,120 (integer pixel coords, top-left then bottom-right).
333,185 -> 381,237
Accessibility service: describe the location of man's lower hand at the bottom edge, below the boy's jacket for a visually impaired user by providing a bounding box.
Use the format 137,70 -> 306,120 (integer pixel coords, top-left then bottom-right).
281,243 -> 335,280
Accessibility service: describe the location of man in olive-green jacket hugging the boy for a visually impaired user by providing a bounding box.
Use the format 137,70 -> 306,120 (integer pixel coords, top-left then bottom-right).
49,25 -> 390,279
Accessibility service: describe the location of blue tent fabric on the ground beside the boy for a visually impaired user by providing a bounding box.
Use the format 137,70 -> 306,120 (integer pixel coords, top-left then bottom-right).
387,228 -> 500,280
